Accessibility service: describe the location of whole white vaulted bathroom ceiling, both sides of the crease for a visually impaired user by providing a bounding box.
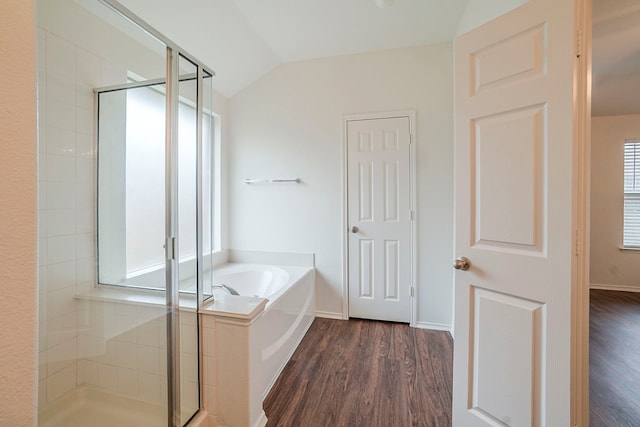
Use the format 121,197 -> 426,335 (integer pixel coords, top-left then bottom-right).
119,0 -> 468,97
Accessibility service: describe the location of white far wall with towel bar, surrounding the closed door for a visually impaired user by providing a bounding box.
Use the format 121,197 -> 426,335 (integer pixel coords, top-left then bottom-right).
229,43 -> 453,327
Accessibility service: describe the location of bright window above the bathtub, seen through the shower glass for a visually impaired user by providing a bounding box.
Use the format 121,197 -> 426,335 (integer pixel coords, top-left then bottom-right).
97,70 -> 221,291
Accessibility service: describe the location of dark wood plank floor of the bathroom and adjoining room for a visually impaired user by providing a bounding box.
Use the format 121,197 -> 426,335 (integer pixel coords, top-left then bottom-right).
264,290 -> 640,427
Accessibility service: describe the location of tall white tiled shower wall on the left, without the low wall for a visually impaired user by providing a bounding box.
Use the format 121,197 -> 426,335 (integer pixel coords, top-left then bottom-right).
38,29 -> 126,406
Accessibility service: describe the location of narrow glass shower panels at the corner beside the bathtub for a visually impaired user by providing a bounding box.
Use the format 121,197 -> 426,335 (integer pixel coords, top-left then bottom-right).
174,51 -> 214,424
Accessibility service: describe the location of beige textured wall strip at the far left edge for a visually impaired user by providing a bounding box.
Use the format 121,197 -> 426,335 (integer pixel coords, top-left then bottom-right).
0,0 -> 37,426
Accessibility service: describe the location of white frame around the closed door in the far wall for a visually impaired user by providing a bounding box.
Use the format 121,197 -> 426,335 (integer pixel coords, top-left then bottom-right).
340,110 -> 418,327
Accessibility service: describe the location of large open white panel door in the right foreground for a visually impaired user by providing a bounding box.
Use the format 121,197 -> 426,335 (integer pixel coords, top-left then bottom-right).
453,0 -> 575,427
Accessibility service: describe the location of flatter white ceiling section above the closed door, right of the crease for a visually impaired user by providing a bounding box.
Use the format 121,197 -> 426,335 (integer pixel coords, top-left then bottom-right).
234,0 -> 467,62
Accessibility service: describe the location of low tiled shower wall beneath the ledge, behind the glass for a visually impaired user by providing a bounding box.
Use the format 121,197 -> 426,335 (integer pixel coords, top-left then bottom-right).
77,300 -> 199,413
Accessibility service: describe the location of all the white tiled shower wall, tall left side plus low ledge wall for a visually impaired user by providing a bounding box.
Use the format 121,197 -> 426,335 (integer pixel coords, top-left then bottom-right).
38,29 -> 202,414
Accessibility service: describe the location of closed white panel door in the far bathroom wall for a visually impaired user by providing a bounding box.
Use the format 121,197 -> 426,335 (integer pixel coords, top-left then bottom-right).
347,117 -> 411,323
